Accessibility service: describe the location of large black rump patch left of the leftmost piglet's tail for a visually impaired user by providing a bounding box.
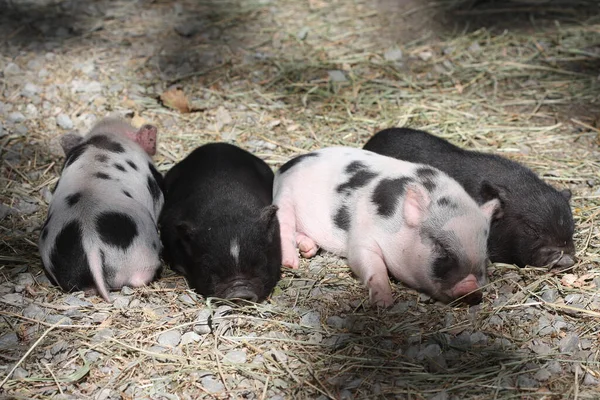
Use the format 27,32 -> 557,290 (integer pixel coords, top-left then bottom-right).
50,220 -> 94,292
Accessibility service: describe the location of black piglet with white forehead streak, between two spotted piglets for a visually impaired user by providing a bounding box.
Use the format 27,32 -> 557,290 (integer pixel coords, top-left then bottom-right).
159,143 -> 281,302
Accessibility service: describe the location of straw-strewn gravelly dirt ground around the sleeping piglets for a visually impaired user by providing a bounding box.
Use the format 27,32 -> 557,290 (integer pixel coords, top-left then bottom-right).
0,0 -> 600,400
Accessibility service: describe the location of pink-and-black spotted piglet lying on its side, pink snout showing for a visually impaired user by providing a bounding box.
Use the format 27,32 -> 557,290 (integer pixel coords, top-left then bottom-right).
274,147 -> 499,306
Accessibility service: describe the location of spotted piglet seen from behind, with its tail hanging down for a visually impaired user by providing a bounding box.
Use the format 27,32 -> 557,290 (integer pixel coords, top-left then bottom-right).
39,119 -> 164,301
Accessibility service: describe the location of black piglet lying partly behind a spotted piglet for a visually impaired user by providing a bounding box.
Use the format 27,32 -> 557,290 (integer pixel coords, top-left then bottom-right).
364,128 -> 576,268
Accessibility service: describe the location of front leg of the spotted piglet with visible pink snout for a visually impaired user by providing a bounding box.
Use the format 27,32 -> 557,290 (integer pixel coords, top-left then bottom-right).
348,245 -> 394,307
